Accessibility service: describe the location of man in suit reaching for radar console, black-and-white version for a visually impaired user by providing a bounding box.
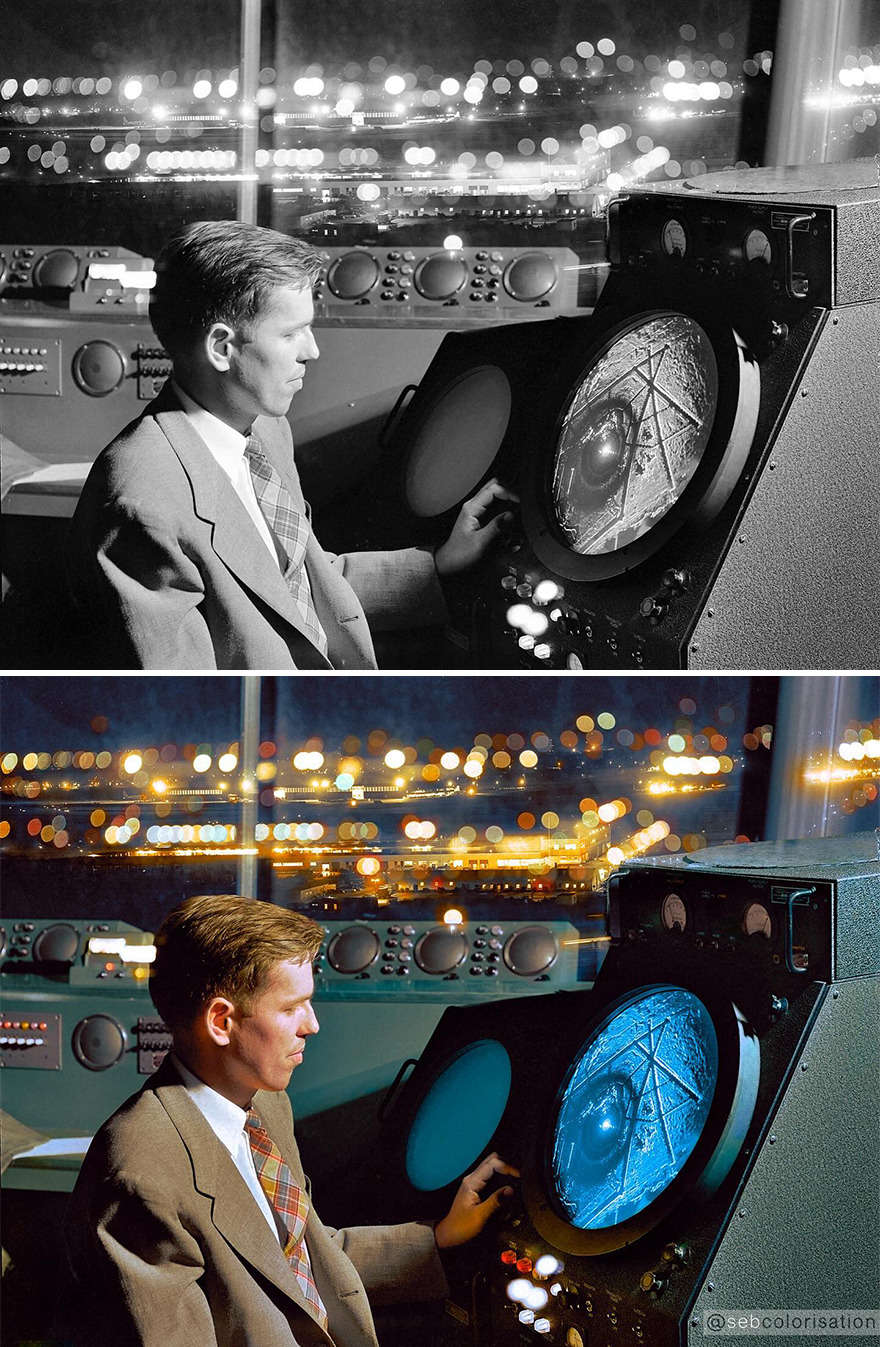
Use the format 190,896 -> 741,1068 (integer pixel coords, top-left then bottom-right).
67,221 -> 513,669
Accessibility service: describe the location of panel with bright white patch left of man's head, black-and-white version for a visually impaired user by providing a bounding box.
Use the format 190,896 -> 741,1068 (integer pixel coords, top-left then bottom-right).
0,244 -> 156,314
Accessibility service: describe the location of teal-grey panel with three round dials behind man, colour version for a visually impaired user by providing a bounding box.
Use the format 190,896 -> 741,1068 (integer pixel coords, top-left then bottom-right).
315,920 -> 581,998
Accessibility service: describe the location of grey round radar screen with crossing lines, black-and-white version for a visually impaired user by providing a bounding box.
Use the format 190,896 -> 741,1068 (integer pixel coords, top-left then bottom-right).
551,313 -> 718,556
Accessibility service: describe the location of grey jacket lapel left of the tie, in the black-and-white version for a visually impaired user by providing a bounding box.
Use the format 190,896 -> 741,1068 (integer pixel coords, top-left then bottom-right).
152,384 -> 330,668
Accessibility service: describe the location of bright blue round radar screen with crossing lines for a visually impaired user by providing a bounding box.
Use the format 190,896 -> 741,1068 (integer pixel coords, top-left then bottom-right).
551,987 -> 718,1230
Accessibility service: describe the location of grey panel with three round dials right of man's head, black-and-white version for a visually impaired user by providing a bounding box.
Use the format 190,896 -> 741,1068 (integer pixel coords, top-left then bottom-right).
315,245 -> 582,323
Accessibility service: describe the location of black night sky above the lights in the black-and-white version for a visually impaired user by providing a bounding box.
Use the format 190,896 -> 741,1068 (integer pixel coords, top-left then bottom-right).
1,0 -> 760,79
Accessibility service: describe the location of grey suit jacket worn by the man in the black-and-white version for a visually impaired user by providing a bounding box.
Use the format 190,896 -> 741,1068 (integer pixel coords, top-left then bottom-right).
67,383 -> 446,669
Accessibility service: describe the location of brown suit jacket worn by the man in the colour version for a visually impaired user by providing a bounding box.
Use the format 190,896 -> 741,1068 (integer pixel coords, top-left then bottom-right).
66,1061 -> 447,1347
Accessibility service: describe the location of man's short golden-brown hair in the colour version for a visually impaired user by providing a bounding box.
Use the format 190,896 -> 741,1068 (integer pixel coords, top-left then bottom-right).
150,893 -> 323,1030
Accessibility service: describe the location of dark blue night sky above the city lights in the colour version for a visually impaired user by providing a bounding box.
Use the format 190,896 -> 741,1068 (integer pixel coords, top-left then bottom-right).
1,674 -> 772,753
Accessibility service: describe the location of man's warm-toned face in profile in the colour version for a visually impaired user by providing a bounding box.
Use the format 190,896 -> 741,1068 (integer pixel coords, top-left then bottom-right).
226,960 -> 318,1096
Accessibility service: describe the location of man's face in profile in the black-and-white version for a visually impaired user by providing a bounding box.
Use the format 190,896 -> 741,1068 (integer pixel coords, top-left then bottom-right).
228,286 -> 318,422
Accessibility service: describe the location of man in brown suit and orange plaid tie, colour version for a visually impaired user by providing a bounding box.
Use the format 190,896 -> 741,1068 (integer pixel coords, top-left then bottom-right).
67,896 -> 516,1347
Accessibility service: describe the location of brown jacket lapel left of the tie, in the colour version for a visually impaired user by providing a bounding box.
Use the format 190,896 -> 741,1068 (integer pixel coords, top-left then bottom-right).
146,1061 -> 329,1343
